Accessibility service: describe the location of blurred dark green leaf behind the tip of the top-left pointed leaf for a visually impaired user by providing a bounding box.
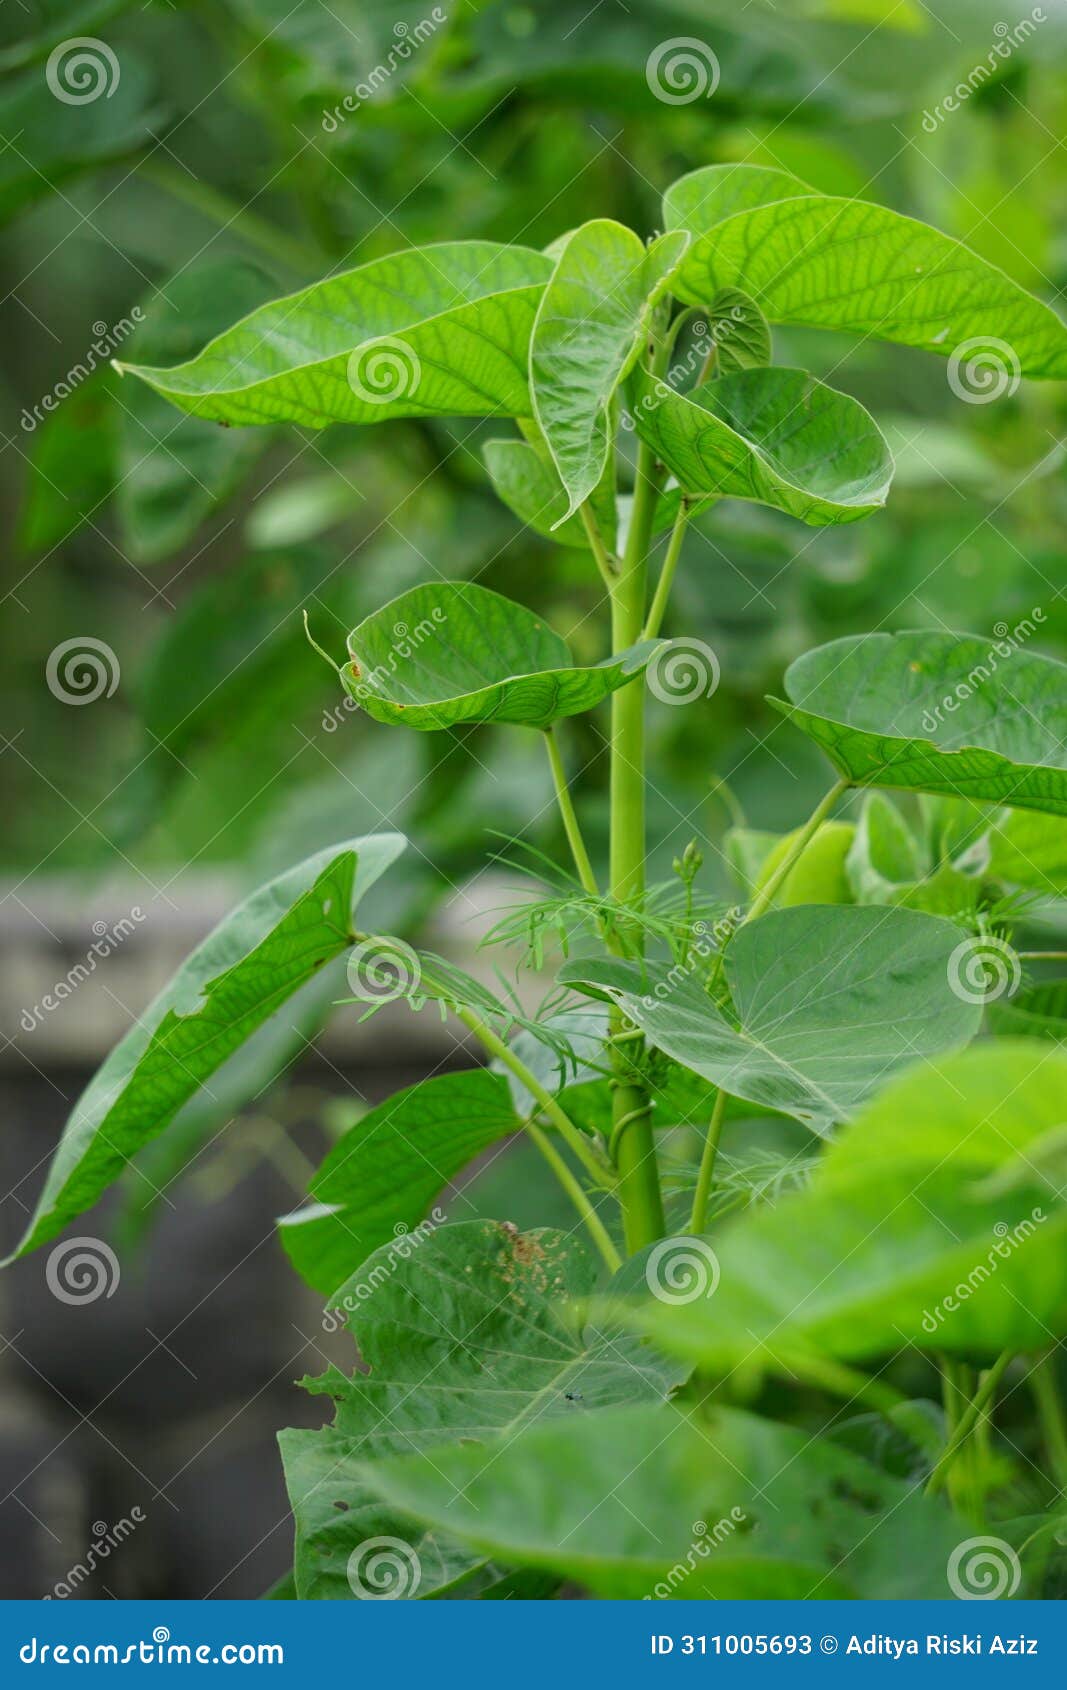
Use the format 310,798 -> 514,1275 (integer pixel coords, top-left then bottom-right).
117,262 -> 279,563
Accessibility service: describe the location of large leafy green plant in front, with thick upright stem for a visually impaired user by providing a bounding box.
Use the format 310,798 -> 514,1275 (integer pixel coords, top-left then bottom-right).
19,166 -> 1067,1597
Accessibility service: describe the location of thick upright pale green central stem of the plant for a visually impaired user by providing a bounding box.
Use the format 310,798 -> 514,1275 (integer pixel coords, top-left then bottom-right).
610,444 -> 665,1252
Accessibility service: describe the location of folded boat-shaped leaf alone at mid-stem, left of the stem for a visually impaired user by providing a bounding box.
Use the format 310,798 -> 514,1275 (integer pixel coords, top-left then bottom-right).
342,581 -> 659,732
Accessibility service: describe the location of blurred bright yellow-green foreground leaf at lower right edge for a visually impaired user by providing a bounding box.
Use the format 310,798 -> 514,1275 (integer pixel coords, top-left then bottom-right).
627,1039 -> 1067,1372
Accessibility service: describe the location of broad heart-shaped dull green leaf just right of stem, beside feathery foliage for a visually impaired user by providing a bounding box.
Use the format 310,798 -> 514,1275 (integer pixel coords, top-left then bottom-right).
560,904 -> 981,1134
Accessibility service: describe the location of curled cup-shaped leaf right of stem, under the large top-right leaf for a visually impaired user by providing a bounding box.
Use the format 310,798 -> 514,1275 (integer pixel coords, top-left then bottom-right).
631,368 -> 893,524
